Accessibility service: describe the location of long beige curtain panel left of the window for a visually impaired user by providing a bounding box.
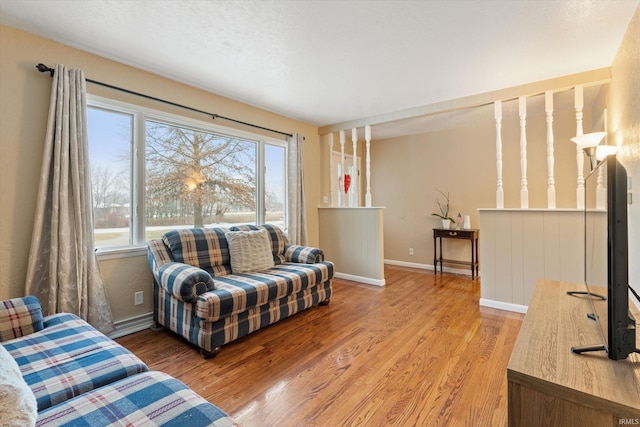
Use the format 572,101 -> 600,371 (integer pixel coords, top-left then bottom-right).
26,64 -> 113,333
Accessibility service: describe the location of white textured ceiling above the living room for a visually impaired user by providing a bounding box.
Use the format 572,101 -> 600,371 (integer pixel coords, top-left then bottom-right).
0,0 -> 638,137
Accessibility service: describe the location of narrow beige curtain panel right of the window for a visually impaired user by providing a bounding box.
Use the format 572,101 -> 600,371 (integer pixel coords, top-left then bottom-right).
287,133 -> 307,245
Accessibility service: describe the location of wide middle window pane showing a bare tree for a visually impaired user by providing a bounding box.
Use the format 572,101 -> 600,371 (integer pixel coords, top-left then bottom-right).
146,121 -> 256,232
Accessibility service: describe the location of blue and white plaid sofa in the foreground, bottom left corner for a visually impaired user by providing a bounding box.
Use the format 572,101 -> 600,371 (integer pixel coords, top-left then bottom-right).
0,296 -> 236,427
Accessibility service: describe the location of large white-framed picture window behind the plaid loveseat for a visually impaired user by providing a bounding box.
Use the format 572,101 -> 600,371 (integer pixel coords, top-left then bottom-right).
87,97 -> 286,249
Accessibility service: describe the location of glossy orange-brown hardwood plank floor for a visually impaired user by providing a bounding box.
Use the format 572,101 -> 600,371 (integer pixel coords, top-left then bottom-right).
117,266 -> 523,427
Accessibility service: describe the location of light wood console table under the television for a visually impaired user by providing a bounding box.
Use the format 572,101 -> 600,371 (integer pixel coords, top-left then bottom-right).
507,280 -> 640,427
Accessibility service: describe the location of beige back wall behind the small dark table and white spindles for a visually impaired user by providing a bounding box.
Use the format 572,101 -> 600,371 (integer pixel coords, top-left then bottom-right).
371,94 -> 591,270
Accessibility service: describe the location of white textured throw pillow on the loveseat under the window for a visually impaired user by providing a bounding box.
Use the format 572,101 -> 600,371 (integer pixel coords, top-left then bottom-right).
225,229 -> 274,273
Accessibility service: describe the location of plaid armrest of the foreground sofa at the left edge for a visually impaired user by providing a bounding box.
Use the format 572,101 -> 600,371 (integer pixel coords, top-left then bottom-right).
0,296 -> 44,342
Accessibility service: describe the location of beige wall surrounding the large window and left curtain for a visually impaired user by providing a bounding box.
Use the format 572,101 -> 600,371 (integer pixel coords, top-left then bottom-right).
0,26 -> 321,320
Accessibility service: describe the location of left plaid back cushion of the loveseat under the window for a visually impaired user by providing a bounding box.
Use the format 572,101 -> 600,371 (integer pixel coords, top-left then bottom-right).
162,227 -> 231,276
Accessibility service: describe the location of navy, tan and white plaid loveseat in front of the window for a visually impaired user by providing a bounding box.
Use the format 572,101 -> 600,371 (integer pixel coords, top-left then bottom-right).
148,224 -> 334,358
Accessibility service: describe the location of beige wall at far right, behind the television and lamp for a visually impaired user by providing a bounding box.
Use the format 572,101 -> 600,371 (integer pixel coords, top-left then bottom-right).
608,7 -> 640,307
